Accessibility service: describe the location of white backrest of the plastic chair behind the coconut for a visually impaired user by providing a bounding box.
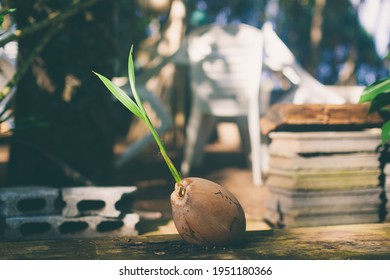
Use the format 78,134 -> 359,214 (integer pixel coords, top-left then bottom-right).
188,24 -> 263,116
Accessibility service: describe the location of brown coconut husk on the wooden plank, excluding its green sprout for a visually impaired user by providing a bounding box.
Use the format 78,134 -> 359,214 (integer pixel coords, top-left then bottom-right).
171,177 -> 246,246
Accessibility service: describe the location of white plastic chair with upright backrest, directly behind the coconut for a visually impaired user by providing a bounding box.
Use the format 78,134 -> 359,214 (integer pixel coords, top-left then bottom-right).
181,24 -> 263,185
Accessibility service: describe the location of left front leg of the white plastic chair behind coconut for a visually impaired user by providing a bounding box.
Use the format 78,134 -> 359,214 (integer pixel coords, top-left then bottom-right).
181,107 -> 216,177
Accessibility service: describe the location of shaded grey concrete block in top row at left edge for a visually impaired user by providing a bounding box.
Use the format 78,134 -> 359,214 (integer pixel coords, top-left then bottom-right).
0,186 -> 61,217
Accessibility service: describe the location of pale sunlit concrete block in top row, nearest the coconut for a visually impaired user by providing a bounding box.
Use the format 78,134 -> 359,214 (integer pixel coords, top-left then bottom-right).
62,186 -> 137,217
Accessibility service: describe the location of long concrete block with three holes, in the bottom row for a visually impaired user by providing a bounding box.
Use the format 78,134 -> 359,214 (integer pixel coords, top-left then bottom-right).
3,214 -> 139,241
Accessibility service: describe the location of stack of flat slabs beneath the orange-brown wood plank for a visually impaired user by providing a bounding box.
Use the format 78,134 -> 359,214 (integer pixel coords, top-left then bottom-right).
265,129 -> 382,227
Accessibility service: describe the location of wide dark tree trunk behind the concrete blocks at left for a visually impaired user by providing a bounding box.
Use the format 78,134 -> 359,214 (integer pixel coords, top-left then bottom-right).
8,0 -> 115,186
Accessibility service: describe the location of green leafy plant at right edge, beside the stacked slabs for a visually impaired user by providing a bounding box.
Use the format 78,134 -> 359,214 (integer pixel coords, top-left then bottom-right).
359,52 -> 390,145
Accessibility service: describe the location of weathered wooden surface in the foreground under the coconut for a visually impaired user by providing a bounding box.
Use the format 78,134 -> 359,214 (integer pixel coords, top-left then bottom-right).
0,223 -> 390,260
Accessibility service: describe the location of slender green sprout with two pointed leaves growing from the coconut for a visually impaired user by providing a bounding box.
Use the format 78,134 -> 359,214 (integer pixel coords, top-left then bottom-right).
93,46 -> 181,184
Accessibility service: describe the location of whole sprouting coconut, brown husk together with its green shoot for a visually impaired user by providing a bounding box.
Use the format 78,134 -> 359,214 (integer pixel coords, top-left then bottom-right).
94,48 -> 246,246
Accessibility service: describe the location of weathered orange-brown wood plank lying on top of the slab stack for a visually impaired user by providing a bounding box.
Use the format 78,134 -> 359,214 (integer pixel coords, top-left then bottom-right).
261,104 -> 383,134
